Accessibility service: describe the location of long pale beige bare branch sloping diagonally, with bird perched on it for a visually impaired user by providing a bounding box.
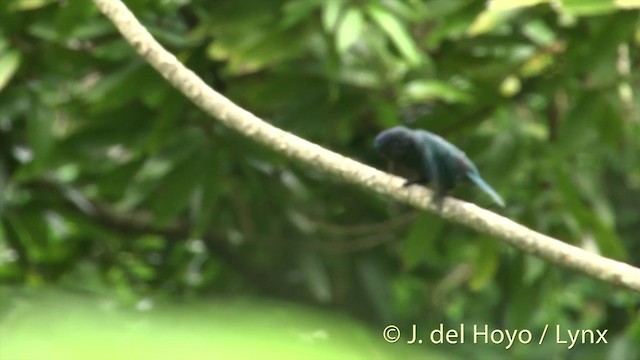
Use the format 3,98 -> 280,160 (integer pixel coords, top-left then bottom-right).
93,0 -> 640,292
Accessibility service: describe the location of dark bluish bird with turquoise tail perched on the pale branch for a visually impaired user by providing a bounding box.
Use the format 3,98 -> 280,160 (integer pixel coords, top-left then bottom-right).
374,126 -> 505,207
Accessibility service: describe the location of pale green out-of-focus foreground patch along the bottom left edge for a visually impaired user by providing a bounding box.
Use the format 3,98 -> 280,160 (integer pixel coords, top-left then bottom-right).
0,289 -> 453,360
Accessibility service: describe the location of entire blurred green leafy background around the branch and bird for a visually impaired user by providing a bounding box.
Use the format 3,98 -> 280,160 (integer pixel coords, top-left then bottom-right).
0,0 -> 640,360
